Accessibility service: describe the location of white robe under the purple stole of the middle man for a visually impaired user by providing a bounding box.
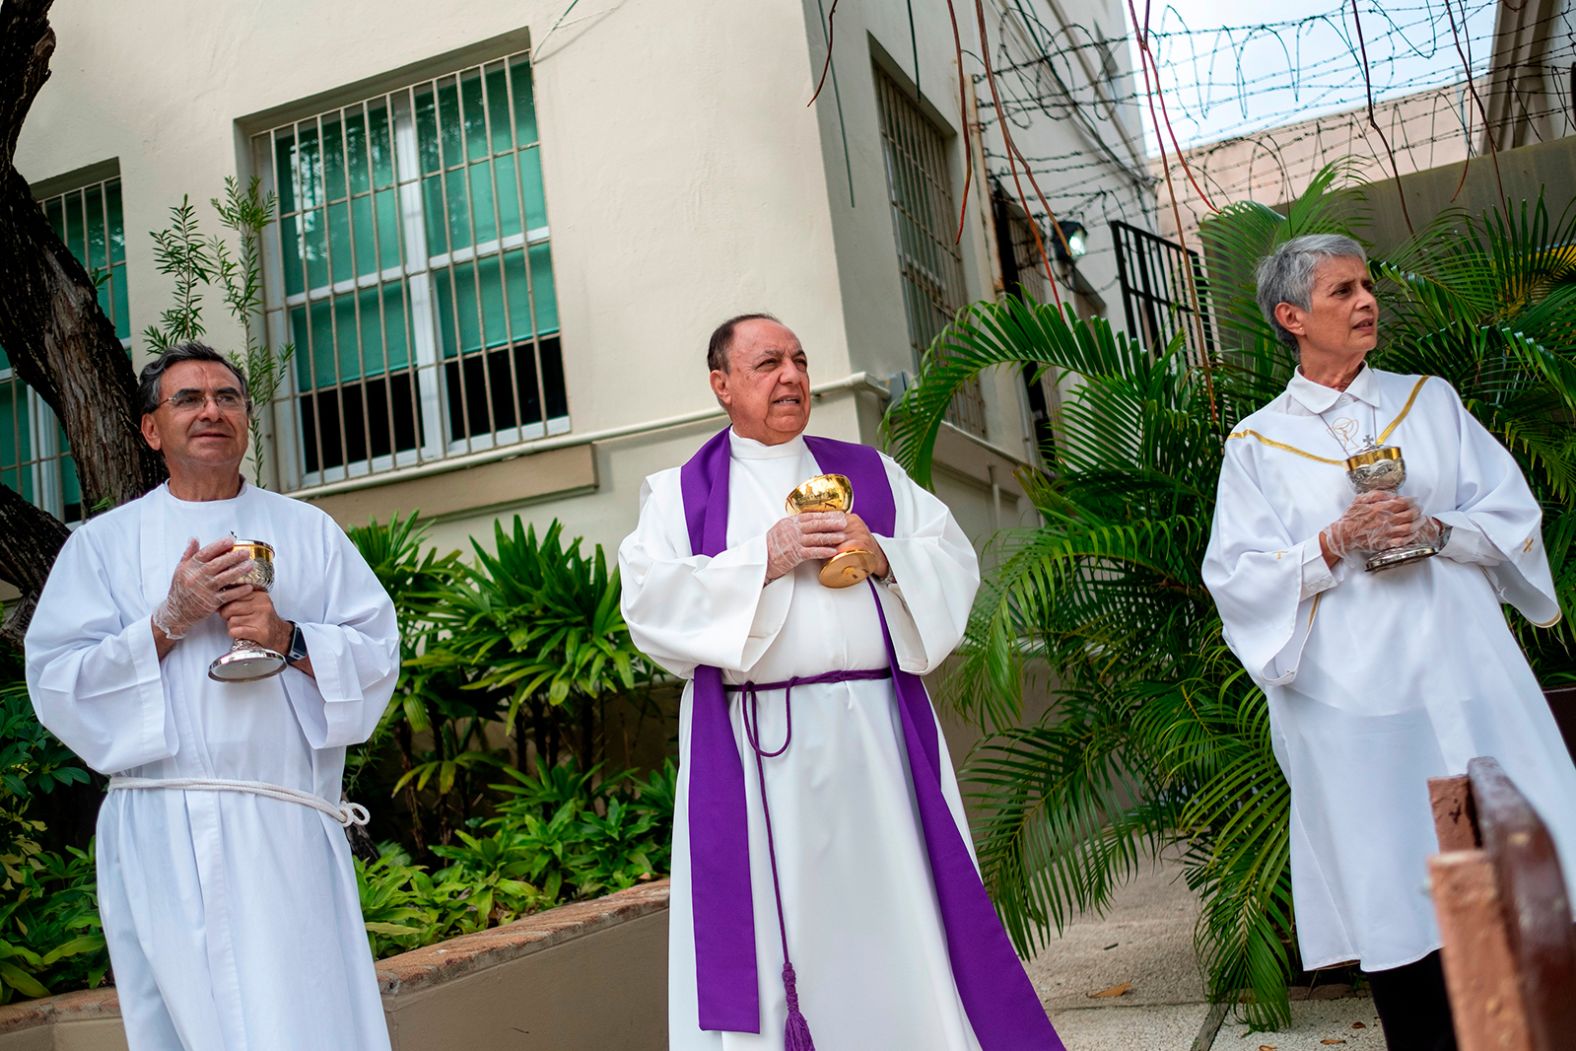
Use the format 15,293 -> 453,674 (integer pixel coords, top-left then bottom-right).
618,433 -> 979,1051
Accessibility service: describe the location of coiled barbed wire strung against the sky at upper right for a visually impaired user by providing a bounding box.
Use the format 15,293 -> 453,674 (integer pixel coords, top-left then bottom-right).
969,0 -> 1576,292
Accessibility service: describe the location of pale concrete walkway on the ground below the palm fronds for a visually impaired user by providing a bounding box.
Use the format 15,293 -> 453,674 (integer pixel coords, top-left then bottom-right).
1029,862 -> 1385,1051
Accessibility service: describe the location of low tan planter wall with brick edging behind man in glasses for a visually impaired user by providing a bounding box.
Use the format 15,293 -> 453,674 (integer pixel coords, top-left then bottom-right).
0,879 -> 668,1051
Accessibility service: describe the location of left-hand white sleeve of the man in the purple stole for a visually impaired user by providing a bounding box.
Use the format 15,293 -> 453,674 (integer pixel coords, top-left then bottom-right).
618,470 -> 794,679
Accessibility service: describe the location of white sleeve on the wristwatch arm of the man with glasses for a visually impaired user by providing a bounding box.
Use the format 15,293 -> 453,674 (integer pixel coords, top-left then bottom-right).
281,520 -> 400,748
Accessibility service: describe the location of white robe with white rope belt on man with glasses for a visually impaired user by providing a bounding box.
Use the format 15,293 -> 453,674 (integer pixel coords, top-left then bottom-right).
27,485 -> 399,1051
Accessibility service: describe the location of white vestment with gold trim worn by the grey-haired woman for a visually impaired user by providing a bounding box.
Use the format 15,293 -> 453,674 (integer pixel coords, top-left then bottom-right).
1204,367 -> 1576,971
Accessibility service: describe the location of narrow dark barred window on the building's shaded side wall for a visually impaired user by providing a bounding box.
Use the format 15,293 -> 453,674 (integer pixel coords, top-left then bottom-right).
876,69 -> 985,436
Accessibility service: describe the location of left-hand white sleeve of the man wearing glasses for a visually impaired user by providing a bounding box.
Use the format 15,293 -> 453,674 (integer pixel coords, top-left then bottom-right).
24,526 -> 180,774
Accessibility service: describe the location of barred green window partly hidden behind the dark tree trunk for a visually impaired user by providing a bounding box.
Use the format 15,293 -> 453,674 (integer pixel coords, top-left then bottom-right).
0,178 -> 131,523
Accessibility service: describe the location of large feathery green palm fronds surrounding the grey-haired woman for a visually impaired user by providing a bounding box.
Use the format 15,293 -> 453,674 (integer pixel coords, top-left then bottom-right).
886,169 -> 1576,1027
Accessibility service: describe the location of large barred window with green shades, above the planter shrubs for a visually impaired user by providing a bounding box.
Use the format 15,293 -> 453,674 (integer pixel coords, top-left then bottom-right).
252,52 -> 569,488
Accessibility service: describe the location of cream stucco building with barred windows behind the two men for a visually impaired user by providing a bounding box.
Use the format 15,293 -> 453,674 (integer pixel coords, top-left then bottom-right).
0,0 -> 1154,567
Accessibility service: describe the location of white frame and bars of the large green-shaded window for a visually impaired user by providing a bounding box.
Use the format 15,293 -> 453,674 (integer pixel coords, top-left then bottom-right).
249,49 -> 571,492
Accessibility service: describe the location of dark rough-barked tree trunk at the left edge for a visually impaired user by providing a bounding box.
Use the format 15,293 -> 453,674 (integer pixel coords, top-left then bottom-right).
0,0 -> 164,635
